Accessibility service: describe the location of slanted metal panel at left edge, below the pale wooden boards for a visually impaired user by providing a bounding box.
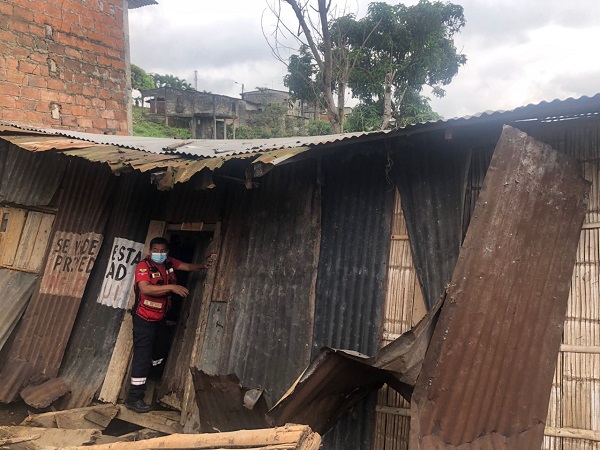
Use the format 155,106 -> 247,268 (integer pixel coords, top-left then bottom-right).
0,268 -> 37,349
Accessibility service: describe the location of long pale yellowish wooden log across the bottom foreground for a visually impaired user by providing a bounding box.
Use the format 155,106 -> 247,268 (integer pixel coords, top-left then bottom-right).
59,425 -> 321,450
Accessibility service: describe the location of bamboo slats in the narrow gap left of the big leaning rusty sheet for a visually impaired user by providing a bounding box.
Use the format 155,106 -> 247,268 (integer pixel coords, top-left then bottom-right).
373,191 -> 427,450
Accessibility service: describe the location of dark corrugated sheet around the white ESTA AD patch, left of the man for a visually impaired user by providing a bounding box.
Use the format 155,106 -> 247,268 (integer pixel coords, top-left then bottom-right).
60,174 -> 157,408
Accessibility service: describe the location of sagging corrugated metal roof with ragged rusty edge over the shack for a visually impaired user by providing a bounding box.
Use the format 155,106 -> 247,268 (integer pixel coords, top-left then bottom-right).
0,94 -> 600,189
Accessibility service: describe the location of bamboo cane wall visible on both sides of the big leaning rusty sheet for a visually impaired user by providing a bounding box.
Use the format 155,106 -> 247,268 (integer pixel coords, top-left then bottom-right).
373,119 -> 600,450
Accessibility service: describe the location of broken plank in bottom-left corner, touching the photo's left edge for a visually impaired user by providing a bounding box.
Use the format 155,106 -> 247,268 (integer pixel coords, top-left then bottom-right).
0,426 -> 102,448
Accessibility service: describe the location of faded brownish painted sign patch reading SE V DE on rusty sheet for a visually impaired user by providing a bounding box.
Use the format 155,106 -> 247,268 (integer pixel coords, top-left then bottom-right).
40,231 -> 102,298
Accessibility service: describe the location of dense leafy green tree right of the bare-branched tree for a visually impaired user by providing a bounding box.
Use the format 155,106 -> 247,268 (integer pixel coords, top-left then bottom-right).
349,0 -> 466,129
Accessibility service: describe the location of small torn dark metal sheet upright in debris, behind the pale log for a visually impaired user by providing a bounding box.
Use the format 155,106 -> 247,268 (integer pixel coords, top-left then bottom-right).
191,368 -> 269,433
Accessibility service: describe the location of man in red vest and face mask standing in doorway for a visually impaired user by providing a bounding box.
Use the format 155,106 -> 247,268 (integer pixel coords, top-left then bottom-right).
125,237 -> 213,413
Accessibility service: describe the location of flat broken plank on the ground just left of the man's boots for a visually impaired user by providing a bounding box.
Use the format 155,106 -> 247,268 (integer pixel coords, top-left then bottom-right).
21,404 -> 119,429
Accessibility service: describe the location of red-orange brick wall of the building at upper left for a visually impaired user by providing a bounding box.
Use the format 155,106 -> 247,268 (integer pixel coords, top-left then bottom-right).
0,0 -> 128,134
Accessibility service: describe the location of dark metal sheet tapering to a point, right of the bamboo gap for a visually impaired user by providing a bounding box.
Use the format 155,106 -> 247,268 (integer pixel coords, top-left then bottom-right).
392,132 -> 471,309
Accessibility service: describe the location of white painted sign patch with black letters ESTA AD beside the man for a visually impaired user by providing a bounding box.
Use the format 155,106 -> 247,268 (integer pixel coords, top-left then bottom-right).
98,238 -> 144,309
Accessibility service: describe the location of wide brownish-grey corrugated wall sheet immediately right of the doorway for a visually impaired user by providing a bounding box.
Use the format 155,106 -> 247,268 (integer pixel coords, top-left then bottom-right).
213,161 -> 321,400
